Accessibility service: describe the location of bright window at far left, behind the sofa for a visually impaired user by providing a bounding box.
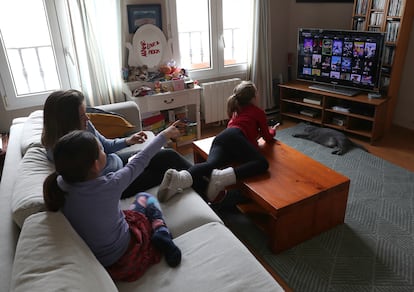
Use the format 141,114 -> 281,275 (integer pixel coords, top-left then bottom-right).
0,0 -> 75,110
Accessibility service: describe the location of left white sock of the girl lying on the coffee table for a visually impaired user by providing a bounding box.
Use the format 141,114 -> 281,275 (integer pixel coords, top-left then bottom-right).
158,169 -> 193,202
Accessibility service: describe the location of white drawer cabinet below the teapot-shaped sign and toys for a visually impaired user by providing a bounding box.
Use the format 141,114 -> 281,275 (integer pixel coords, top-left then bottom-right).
123,82 -> 202,139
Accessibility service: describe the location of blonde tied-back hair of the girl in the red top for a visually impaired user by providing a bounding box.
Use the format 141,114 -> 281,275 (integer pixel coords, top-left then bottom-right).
227,81 -> 257,119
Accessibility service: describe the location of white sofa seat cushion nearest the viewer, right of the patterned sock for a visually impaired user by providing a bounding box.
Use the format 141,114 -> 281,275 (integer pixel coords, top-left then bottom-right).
116,223 -> 284,292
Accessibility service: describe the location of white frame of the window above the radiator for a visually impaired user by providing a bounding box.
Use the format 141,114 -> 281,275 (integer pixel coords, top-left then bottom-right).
169,0 -> 251,80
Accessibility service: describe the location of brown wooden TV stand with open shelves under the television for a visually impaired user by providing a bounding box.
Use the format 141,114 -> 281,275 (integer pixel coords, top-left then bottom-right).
279,81 -> 388,143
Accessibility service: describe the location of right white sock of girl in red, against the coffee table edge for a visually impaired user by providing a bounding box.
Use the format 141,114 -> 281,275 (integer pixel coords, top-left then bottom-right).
207,167 -> 236,202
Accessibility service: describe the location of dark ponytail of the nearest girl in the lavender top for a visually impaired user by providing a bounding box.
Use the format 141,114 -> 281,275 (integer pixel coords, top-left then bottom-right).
43,172 -> 66,212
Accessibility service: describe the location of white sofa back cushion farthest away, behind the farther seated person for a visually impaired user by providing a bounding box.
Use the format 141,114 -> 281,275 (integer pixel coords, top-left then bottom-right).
20,110 -> 43,155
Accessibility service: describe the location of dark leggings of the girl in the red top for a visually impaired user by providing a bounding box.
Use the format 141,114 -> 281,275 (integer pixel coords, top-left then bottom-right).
188,128 -> 269,192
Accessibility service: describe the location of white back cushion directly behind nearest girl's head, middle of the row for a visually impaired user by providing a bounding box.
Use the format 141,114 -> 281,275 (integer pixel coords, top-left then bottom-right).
11,146 -> 55,227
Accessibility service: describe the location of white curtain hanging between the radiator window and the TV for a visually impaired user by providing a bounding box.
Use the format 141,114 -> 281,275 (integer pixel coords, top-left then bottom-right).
248,0 -> 275,109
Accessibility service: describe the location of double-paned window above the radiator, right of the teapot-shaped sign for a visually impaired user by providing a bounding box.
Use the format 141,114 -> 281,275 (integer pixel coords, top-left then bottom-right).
171,0 -> 253,79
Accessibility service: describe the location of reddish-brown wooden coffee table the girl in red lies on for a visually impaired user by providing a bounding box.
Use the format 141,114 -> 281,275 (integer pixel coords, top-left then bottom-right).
192,137 -> 350,253
